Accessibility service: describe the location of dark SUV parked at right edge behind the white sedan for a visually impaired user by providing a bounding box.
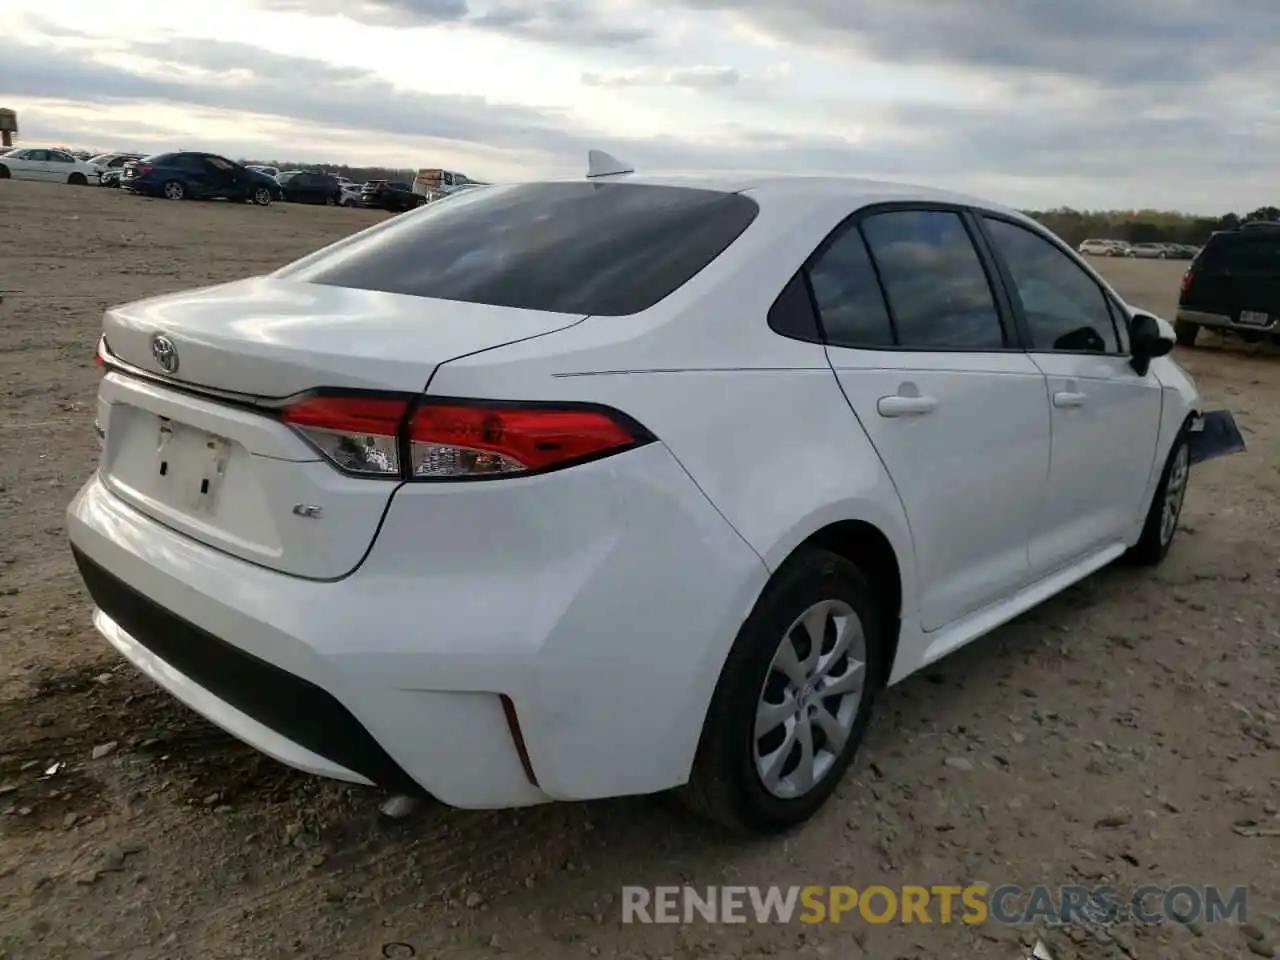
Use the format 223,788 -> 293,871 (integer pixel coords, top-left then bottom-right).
1174,221 -> 1280,347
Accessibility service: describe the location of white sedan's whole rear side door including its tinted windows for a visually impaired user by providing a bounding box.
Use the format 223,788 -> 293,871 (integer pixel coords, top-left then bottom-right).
809,207 -> 1050,631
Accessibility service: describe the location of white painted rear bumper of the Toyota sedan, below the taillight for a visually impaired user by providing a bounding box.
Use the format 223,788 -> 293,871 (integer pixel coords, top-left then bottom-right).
68,444 -> 767,808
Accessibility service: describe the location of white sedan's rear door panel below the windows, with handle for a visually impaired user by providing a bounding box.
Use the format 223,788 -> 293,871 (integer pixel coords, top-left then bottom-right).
828,347 -> 1050,631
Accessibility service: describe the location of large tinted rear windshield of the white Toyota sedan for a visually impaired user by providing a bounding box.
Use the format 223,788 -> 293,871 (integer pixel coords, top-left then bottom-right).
276,182 -> 759,316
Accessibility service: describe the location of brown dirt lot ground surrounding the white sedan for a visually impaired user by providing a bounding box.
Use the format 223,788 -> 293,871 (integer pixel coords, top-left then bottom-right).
0,182 -> 1280,960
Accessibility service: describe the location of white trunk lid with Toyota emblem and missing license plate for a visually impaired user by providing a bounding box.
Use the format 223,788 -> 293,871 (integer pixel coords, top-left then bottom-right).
99,279 -> 582,580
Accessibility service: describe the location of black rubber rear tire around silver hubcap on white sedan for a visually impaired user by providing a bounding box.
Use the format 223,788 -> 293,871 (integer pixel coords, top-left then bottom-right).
676,549 -> 888,833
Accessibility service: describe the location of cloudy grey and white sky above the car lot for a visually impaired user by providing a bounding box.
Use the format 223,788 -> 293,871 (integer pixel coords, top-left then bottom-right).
0,0 -> 1280,212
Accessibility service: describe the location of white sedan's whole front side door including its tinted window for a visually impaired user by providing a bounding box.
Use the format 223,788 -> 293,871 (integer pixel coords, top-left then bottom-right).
983,218 -> 1161,575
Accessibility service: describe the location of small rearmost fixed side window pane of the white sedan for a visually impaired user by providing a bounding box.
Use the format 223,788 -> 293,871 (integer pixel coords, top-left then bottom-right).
809,229 -> 893,347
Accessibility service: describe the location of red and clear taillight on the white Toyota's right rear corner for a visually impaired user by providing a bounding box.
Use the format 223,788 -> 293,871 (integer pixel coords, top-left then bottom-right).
283,394 -> 653,480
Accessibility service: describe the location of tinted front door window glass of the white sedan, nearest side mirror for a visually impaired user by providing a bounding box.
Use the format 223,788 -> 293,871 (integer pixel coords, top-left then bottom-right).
987,219 -> 1120,353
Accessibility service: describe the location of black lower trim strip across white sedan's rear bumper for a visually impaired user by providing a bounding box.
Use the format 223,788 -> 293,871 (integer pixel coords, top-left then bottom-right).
72,547 -> 424,794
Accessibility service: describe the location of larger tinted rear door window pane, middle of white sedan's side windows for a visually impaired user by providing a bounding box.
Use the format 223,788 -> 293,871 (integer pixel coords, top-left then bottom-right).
861,210 -> 1005,349
